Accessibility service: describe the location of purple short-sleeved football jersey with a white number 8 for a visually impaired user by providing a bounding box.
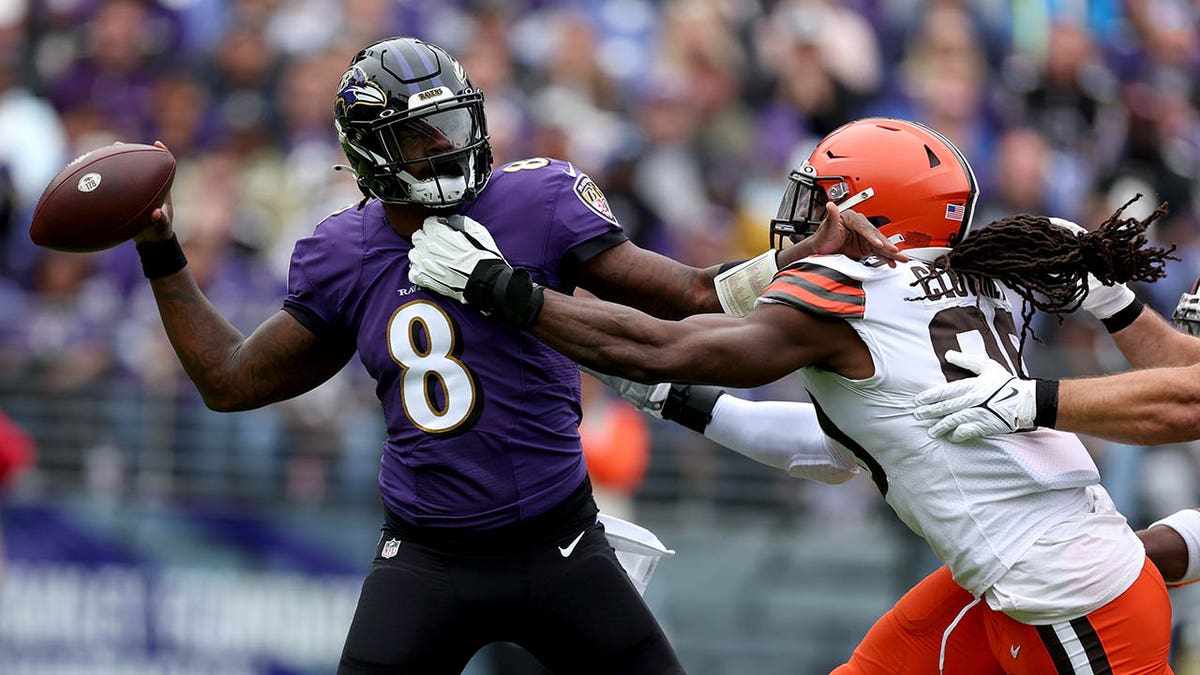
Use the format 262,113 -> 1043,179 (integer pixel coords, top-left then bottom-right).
287,159 -> 624,530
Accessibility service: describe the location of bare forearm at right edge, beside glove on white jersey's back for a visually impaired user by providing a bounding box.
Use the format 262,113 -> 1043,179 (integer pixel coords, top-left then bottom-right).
1054,366 -> 1200,444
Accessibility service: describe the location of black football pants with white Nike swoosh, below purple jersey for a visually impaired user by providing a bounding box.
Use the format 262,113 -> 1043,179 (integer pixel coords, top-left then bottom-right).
337,514 -> 684,675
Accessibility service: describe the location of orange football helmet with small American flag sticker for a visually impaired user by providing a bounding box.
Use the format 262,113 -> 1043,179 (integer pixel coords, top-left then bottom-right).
770,118 -> 978,250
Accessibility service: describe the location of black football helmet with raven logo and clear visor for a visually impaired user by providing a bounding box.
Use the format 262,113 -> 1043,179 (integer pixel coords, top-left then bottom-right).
334,37 -> 492,209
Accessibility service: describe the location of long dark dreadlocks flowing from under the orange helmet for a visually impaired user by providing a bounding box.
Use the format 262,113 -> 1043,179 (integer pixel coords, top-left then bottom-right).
932,195 -> 1178,353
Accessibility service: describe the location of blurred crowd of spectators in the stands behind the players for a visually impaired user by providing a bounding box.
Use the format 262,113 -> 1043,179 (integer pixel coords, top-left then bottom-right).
0,0 -> 1200,521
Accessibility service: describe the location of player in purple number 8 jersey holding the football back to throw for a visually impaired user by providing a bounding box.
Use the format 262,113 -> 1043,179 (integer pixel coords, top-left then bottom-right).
134,37 -> 902,675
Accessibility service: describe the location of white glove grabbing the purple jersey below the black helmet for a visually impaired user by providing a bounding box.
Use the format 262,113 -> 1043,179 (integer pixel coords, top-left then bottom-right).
408,215 -> 508,303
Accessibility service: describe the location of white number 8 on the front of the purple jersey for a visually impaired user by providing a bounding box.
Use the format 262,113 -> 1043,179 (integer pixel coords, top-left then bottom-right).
388,300 -> 484,434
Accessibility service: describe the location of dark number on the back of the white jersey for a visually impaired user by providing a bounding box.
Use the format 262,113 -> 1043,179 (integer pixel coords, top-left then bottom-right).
929,306 -> 1024,382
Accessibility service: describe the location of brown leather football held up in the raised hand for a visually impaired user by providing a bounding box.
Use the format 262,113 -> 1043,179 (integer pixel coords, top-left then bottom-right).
29,143 -> 175,252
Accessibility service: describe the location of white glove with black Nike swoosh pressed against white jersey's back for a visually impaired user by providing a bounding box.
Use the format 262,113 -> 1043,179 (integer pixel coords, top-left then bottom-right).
913,352 -> 1037,443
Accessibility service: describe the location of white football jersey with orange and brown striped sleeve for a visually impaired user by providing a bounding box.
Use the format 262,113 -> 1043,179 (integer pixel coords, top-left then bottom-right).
760,256 -> 1144,609
